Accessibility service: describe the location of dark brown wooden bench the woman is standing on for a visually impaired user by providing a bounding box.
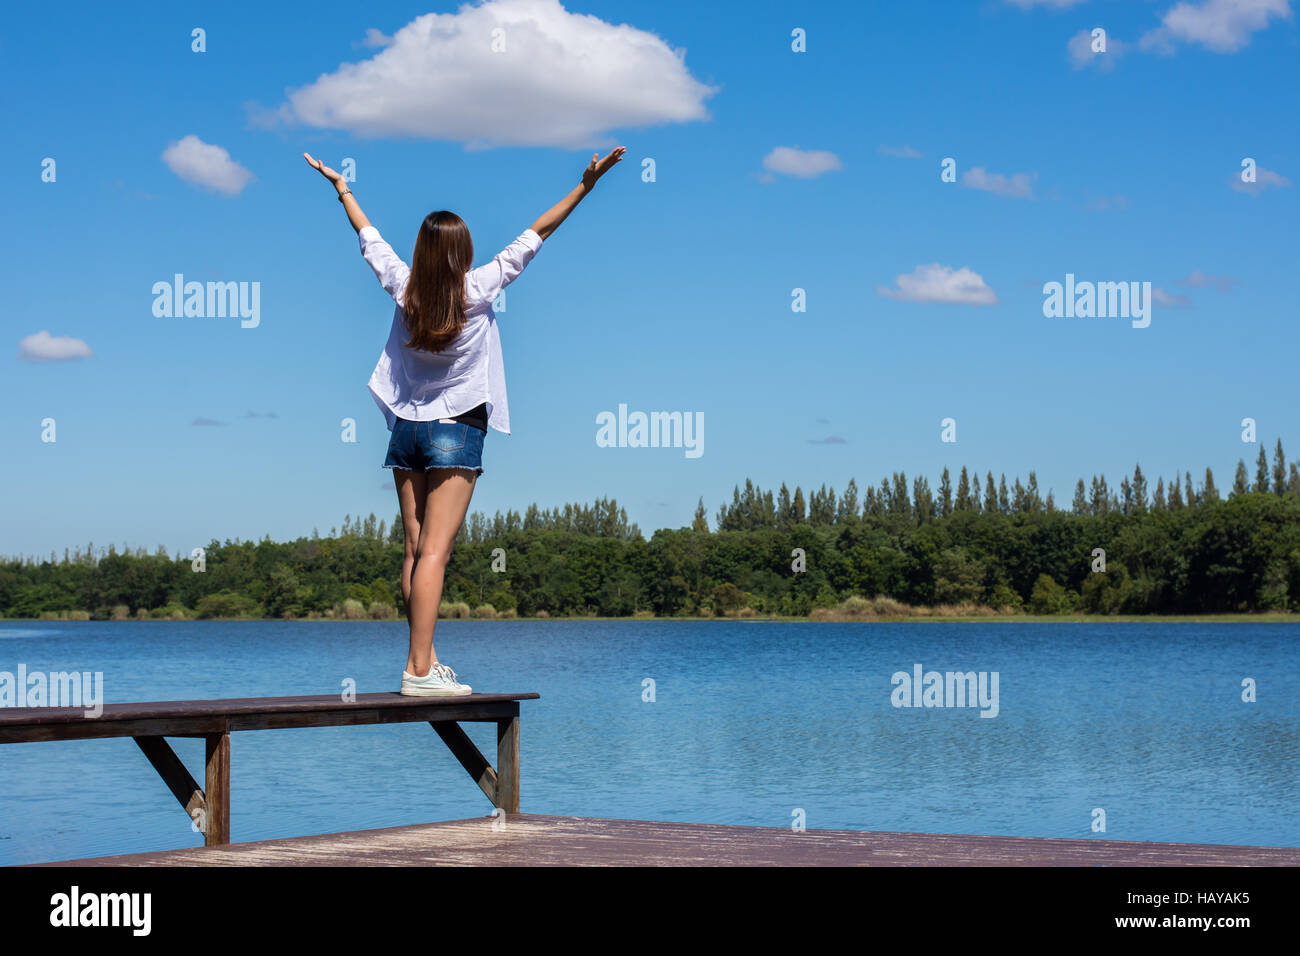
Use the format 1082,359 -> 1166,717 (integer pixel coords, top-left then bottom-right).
0,693 -> 540,847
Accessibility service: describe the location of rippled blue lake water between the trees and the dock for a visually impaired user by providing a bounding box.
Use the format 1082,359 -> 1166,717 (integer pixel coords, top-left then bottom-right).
0,620 -> 1300,864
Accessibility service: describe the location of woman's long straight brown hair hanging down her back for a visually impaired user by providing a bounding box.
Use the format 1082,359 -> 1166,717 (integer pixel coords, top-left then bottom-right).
403,209 -> 475,352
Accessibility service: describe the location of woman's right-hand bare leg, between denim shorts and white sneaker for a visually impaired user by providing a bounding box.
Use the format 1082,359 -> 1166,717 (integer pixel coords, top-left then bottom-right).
402,468 -> 478,678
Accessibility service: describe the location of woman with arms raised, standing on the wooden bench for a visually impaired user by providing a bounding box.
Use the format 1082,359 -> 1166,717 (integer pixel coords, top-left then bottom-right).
303,146 -> 627,697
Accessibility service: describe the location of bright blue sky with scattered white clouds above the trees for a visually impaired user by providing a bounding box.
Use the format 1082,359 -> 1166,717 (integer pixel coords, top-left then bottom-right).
0,0 -> 1300,554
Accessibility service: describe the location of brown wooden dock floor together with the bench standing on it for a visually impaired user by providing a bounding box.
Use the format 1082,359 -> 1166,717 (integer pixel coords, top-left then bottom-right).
10,693 -> 1300,866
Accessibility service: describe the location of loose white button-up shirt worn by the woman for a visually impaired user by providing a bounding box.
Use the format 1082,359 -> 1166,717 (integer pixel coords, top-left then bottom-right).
358,226 -> 542,434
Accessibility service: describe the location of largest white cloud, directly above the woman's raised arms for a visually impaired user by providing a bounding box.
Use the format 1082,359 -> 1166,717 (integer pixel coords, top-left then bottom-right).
252,0 -> 718,148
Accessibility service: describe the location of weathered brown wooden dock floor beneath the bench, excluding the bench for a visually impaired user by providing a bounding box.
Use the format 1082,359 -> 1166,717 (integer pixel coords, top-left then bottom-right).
39,813 -> 1300,866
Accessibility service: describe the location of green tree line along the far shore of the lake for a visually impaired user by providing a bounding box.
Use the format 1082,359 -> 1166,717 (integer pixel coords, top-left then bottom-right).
0,441 -> 1300,618
